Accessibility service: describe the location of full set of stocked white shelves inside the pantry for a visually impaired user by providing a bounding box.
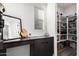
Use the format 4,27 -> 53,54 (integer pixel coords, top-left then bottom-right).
57,12 -> 77,42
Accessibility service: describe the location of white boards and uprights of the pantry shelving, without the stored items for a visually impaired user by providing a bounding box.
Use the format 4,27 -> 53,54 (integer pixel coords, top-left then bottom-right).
57,16 -> 77,42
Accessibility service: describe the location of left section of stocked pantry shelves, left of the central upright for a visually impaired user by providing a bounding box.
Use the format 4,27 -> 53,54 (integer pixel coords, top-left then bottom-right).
57,14 -> 67,41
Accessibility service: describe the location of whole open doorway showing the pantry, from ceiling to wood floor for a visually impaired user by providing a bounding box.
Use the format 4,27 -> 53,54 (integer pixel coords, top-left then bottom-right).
56,3 -> 77,56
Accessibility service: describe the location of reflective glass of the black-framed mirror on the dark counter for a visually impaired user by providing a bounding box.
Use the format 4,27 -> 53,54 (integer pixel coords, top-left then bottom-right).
3,16 -> 21,40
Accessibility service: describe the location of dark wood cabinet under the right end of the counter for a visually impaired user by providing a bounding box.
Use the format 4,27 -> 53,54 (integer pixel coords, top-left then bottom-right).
30,38 -> 54,56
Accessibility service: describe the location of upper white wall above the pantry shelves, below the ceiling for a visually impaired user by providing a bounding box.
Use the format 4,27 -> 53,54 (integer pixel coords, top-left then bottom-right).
57,4 -> 76,16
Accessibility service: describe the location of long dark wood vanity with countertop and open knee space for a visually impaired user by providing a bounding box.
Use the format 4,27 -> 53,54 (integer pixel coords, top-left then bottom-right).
0,36 -> 54,56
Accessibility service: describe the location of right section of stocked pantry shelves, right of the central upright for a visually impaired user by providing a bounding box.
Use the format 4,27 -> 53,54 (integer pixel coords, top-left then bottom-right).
68,15 -> 77,41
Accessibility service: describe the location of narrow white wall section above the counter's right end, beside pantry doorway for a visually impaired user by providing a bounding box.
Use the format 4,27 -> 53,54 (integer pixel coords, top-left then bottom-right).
47,3 -> 55,36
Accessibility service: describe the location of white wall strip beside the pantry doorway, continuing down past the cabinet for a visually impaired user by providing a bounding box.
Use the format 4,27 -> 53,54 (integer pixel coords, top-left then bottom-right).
47,3 -> 57,55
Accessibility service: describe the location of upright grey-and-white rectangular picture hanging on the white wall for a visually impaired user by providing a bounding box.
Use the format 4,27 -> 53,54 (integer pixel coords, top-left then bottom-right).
34,7 -> 45,30
